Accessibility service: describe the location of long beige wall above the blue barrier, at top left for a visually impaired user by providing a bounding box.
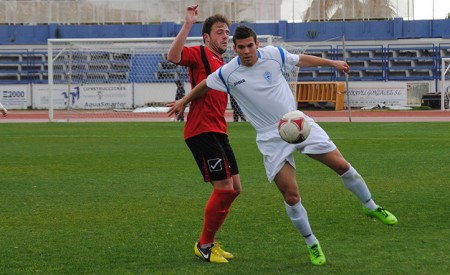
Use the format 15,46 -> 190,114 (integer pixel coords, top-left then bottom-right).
0,0 -> 282,24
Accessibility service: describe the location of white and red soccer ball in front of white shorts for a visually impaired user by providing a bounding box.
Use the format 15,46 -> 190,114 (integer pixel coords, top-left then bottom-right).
278,111 -> 311,144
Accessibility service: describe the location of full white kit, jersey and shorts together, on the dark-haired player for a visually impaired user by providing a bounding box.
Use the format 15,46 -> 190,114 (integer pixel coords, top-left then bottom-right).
206,46 -> 336,181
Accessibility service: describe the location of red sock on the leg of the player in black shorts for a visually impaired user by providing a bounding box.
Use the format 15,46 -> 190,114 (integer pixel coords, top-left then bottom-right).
200,189 -> 236,245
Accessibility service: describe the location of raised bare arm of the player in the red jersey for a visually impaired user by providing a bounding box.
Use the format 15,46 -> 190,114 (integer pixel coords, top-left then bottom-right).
167,5 -> 198,64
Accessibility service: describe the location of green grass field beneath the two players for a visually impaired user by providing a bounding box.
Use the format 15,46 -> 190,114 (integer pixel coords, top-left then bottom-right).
0,123 -> 450,274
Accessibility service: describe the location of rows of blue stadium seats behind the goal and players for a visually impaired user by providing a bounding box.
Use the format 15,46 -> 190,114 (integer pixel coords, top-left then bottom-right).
0,43 -> 450,84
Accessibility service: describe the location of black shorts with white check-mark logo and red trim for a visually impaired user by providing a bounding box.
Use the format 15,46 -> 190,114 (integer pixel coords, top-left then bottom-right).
186,133 -> 239,182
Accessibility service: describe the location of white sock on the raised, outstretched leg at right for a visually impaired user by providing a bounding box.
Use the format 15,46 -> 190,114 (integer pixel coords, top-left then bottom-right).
340,166 -> 377,210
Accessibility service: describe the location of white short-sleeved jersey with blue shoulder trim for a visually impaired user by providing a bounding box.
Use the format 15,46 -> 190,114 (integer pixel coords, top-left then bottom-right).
207,46 -> 299,130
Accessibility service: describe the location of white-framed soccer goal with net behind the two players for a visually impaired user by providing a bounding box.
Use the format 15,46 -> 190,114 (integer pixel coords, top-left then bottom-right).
48,35 -> 286,121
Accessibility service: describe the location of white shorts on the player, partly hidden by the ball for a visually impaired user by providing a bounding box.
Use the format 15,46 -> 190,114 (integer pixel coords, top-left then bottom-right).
256,116 -> 336,182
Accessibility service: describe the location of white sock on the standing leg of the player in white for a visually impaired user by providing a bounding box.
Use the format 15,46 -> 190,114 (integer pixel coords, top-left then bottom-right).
284,201 -> 317,246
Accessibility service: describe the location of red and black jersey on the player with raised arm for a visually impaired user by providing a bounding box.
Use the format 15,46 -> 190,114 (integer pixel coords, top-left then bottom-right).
178,46 -> 228,139
